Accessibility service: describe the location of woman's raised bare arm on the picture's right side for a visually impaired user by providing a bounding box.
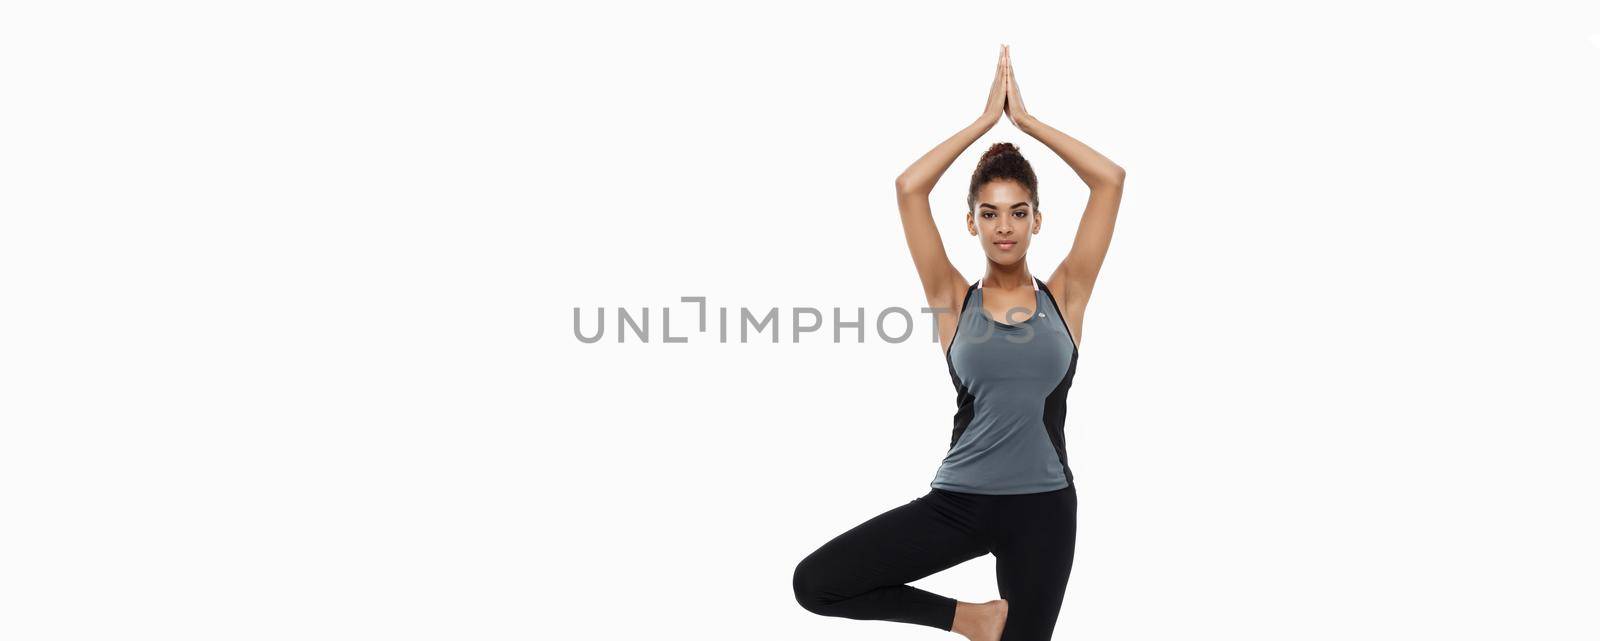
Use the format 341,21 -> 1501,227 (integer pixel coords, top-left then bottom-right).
1005,44 -> 1126,340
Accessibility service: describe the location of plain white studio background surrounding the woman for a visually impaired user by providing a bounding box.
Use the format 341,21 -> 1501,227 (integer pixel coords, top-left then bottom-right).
0,2 -> 1600,639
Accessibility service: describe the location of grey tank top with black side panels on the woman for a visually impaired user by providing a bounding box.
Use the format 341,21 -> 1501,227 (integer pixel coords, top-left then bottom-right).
930,277 -> 1078,494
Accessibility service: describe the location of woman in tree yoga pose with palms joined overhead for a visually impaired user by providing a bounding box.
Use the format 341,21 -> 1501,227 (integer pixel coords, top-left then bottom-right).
794,46 -> 1125,641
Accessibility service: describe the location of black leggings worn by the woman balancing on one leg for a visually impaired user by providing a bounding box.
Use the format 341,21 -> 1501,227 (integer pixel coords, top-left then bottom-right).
794,486 -> 1078,641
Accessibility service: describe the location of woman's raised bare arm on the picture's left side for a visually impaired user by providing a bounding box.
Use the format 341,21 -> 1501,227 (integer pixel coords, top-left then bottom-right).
894,48 -> 1006,312
